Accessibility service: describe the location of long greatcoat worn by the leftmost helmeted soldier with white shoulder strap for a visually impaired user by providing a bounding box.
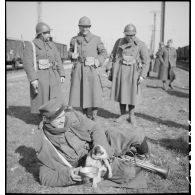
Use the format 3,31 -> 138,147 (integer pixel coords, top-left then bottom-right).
23,38 -> 65,113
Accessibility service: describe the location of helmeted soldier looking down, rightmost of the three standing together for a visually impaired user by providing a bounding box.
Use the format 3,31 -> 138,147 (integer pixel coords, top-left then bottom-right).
107,24 -> 150,125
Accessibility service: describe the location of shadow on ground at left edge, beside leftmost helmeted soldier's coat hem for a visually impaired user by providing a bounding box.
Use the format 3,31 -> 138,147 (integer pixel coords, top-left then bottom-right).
7,106 -> 41,125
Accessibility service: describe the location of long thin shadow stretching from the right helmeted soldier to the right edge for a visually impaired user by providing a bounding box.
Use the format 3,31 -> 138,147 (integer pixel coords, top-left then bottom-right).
135,113 -> 189,130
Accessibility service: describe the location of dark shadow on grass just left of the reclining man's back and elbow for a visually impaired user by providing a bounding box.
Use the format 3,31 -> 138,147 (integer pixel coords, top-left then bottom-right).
15,145 -> 39,182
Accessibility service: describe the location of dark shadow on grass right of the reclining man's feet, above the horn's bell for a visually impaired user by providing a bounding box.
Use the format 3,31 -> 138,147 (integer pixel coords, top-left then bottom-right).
147,137 -> 189,155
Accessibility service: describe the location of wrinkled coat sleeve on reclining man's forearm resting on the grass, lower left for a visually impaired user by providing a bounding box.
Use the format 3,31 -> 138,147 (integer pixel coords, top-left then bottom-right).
39,165 -> 76,187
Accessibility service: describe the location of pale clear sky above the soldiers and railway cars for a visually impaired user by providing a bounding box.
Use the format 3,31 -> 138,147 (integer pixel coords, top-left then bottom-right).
6,1 -> 189,52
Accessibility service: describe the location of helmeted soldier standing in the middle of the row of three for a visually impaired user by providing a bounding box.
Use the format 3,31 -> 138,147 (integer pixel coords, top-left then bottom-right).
69,16 -> 107,120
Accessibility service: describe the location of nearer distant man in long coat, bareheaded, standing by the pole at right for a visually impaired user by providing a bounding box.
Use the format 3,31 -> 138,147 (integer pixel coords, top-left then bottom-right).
158,39 -> 177,90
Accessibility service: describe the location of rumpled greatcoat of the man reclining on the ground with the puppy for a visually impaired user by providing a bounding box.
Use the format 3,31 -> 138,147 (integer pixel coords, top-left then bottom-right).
38,110 -> 145,186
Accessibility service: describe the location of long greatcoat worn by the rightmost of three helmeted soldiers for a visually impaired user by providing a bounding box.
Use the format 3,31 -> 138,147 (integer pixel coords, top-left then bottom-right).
111,38 -> 150,105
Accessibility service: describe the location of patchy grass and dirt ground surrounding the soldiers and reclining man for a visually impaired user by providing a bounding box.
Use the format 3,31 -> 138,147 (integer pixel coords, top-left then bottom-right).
6,66 -> 190,194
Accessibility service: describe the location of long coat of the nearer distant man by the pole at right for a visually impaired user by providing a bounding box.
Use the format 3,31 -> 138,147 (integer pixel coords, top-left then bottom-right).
158,46 -> 177,81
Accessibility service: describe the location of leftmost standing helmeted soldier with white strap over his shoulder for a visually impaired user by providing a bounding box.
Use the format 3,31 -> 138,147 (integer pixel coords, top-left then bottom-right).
23,22 -> 65,118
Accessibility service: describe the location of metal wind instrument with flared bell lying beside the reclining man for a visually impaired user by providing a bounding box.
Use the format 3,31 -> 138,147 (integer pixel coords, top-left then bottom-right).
113,155 -> 169,179
